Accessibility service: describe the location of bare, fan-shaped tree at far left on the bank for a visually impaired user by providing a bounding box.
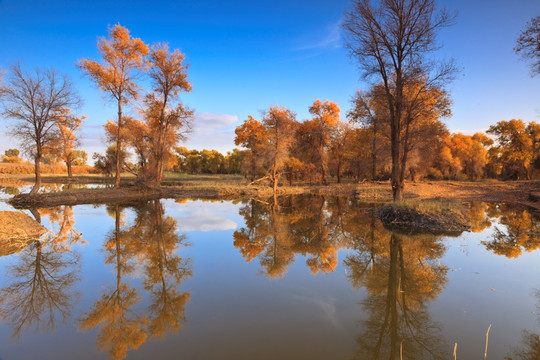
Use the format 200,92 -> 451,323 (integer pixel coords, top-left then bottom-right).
1,64 -> 81,194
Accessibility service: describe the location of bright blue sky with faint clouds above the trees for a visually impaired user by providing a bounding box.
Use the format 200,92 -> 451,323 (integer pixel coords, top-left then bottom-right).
0,0 -> 540,160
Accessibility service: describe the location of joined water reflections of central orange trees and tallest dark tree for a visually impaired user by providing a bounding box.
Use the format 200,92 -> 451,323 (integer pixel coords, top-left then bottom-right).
234,196 -> 449,359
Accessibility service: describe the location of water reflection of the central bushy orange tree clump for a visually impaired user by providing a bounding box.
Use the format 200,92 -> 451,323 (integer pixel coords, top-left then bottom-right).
233,196 -> 341,278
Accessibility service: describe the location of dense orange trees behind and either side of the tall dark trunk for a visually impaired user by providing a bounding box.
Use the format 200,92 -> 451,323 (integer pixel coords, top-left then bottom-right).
235,94 -> 540,185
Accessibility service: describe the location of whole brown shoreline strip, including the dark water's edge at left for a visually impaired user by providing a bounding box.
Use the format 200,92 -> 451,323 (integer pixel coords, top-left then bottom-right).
0,175 -> 540,210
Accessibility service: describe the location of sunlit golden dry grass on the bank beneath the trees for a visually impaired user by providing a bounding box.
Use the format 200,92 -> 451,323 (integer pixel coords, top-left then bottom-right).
0,174 -> 540,210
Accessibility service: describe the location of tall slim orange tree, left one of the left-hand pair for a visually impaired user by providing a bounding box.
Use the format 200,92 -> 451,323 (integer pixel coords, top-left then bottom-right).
79,24 -> 149,188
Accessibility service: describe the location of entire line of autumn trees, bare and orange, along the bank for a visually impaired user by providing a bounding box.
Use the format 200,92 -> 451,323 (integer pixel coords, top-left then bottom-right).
0,0 -> 540,200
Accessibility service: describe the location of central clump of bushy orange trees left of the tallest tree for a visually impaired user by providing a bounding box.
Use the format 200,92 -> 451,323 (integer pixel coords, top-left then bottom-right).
235,99 -> 351,189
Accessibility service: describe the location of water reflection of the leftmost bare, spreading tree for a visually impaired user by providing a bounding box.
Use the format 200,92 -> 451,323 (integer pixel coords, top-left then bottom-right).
0,207 -> 81,338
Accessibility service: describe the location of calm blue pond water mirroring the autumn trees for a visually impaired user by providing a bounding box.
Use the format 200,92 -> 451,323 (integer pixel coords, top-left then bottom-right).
0,189 -> 540,360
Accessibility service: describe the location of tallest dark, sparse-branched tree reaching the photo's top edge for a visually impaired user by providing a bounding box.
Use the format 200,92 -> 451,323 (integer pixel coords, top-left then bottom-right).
343,0 -> 454,201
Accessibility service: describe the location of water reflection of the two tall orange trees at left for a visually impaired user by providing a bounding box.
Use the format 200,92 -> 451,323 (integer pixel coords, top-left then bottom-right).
80,200 -> 191,359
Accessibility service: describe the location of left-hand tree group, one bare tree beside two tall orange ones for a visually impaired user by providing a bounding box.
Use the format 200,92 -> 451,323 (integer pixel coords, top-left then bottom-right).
0,25 -> 193,193
